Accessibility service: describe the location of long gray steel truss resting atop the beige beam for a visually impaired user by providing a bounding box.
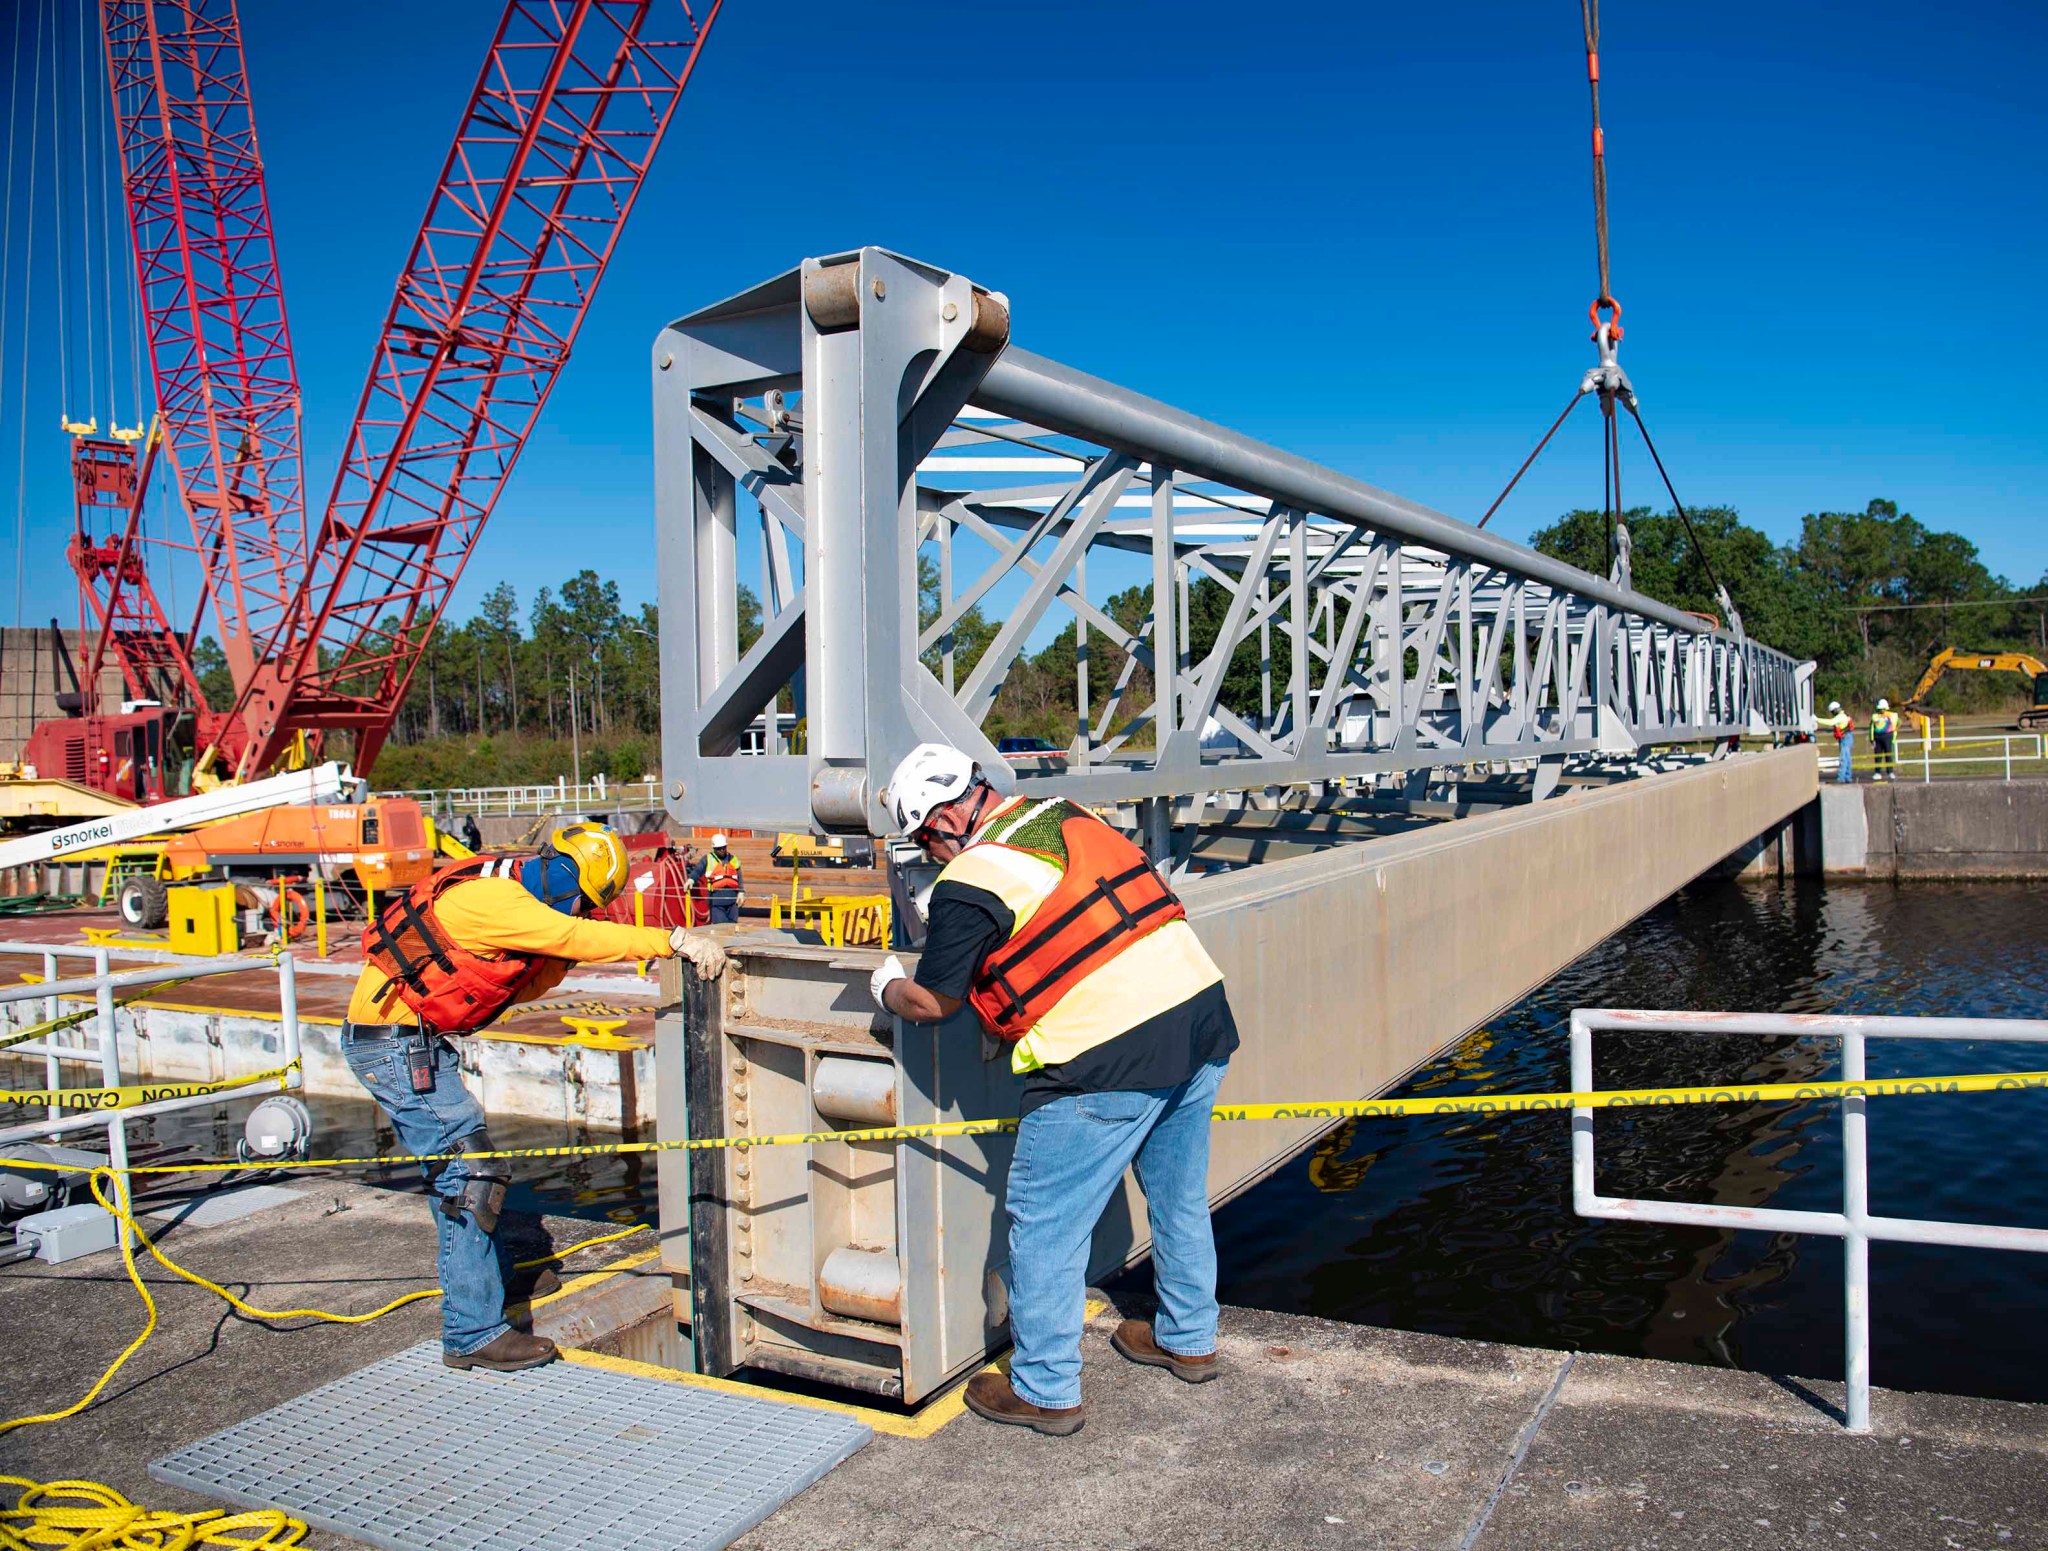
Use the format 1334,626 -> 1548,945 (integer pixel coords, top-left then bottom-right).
653,248 -> 1812,836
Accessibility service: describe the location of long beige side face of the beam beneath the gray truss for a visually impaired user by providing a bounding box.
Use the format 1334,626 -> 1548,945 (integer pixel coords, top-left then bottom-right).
1187,748 -> 1815,1212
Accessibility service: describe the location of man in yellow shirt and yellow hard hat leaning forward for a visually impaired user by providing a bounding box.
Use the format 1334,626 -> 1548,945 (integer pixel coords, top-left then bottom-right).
342,824 -> 725,1373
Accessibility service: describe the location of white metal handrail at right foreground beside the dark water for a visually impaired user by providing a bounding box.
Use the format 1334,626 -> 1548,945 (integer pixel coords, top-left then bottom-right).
1571,1008 -> 2048,1432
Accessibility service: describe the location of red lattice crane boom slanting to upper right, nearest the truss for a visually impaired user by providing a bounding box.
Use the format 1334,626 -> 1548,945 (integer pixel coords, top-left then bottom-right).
236,0 -> 723,772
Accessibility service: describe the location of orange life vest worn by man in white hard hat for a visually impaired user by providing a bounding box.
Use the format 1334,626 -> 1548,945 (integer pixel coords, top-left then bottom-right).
967,803 -> 1188,1045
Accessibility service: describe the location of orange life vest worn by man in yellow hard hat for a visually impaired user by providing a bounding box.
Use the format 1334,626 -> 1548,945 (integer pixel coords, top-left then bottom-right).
362,856 -> 547,1035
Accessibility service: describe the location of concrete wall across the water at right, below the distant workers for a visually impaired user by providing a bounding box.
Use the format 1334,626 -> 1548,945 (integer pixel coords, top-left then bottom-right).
1819,777 -> 2048,879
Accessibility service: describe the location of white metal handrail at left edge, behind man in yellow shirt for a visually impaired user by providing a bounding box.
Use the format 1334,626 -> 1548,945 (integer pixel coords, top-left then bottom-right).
0,942 -> 303,1170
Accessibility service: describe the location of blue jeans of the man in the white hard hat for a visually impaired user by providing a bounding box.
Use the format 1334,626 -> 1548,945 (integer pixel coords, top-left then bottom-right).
1010,1061 -> 1229,1410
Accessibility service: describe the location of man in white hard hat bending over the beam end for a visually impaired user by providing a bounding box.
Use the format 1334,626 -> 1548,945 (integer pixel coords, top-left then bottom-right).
872,744 -> 1237,1436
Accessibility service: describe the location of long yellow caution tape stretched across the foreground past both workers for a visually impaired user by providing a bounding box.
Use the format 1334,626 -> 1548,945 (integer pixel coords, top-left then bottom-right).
0,1072 -> 2048,1174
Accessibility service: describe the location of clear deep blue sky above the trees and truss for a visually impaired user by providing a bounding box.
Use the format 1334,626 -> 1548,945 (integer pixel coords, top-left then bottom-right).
0,0 -> 2048,635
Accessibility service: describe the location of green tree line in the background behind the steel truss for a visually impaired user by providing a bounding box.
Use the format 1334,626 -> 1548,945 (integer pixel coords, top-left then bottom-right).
197,500 -> 2048,789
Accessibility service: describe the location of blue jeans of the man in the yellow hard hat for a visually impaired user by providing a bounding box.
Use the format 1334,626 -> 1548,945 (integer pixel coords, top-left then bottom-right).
342,1039 -> 510,1356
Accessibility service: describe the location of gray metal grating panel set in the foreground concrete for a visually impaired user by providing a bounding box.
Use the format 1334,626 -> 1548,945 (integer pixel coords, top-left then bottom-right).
150,1342 -> 872,1551
